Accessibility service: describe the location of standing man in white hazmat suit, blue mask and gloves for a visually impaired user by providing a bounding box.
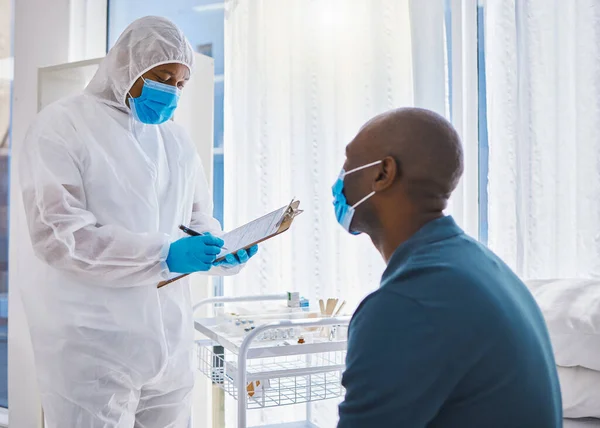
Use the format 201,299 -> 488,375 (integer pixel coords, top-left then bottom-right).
19,17 -> 256,428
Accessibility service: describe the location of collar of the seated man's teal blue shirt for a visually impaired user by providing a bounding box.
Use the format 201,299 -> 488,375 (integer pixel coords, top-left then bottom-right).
382,216 -> 464,281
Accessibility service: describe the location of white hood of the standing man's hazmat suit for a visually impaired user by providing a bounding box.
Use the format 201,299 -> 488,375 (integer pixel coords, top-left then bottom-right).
86,16 -> 194,110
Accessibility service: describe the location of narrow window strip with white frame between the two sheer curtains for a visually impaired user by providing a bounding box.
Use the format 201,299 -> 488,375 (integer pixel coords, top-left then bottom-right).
444,0 -> 488,241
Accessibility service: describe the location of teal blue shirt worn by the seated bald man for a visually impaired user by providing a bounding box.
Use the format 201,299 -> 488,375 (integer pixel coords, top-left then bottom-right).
338,217 -> 562,428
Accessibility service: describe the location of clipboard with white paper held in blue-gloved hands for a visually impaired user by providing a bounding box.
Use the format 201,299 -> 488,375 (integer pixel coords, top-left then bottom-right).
157,199 -> 302,288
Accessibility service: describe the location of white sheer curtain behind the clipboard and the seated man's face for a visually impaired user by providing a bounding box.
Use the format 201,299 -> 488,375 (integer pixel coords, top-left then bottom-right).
224,0 -> 450,427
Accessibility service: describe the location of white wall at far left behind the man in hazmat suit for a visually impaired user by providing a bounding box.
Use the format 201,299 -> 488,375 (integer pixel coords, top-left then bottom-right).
8,0 -> 106,428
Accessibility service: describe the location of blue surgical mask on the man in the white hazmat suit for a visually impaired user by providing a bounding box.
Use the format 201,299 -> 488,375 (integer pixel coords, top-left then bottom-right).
129,77 -> 181,125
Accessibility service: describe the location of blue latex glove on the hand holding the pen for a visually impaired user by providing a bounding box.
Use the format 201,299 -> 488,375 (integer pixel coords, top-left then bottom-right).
167,234 -> 224,273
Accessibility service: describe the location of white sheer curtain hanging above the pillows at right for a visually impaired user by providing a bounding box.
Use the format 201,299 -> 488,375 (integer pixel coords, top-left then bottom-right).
485,0 -> 600,278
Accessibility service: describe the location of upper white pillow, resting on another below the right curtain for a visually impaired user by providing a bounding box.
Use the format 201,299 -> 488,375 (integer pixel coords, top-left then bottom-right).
527,279 -> 600,370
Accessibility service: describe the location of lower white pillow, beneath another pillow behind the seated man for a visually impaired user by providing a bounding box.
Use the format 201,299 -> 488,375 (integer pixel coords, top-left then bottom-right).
558,367 -> 600,418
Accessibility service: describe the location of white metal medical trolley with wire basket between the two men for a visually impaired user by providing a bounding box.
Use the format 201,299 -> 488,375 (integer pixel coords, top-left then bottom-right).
194,293 -> 350,428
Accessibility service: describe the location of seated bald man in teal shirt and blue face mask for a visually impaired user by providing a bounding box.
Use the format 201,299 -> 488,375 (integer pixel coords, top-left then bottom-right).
333,109 -> 562,428
